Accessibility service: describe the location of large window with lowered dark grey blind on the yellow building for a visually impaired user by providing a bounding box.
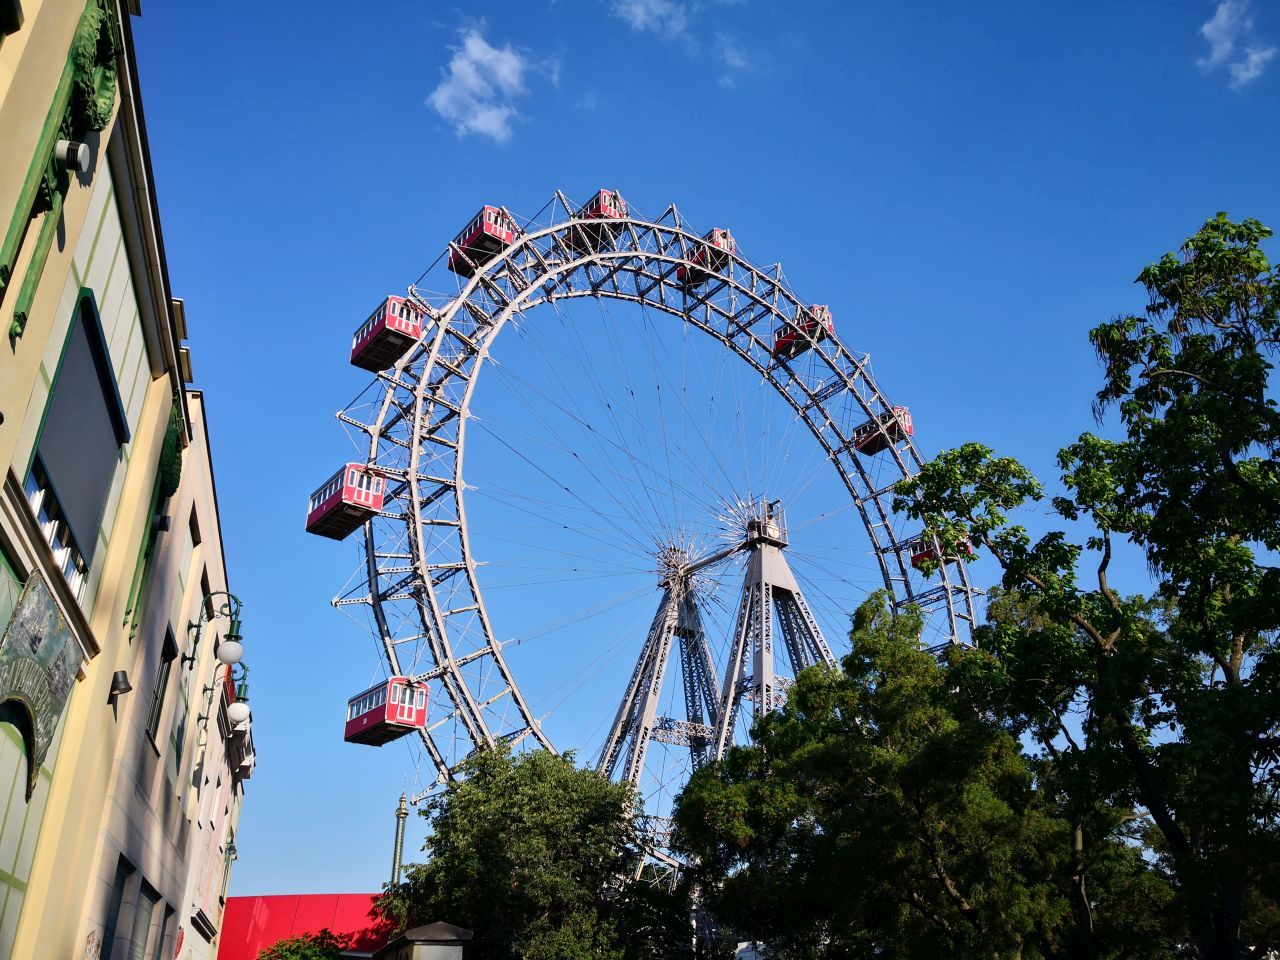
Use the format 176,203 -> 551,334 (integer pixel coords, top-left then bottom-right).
28,289 -> 129,570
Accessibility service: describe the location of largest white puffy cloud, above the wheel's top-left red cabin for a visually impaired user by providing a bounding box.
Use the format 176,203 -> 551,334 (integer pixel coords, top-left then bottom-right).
426,28 -> 529,142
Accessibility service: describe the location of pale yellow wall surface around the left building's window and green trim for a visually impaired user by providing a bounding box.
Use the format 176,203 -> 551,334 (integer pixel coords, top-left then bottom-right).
0,0 -> 249,960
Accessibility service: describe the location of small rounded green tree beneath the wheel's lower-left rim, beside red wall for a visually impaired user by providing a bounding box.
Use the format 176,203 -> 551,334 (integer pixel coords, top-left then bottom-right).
379,748 -> 637,960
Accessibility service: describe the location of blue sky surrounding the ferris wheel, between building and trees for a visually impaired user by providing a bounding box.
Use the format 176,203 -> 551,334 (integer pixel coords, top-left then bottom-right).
134,0 -> 1280,893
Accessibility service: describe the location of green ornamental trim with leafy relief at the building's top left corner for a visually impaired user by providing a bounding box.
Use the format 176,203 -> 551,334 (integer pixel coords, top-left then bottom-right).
0,0 -> 122,339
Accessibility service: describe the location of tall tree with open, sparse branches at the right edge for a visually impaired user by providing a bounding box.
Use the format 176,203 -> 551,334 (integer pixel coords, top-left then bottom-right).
897,214 -> 1280,960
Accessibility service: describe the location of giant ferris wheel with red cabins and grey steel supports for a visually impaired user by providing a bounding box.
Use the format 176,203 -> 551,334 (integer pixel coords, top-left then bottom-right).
307,189 -> 974,859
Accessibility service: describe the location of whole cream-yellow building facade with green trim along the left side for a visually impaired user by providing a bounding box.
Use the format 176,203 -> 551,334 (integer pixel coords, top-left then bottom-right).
0,0 -> 255,960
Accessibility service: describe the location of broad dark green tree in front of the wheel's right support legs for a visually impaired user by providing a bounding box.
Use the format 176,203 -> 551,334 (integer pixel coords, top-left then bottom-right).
676,595 -> 1121,957
